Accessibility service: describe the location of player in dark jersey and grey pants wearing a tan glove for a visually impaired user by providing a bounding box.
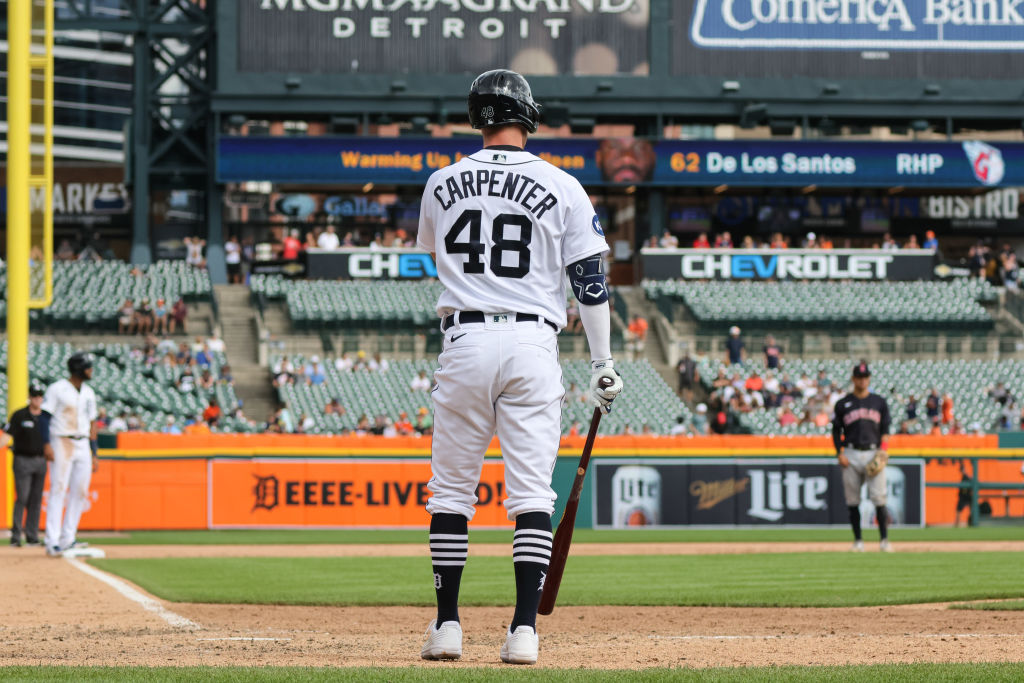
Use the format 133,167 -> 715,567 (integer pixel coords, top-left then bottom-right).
833,361 -> 892,553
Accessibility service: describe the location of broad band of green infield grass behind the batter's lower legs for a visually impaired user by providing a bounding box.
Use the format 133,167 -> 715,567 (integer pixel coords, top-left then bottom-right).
92,550 -> 1024,607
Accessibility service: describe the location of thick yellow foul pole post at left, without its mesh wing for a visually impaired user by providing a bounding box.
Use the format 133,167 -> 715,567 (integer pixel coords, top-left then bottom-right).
7,0 -> 32,415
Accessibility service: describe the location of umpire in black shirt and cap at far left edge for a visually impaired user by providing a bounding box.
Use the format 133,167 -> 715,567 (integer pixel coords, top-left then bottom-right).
3,384 -> 53,547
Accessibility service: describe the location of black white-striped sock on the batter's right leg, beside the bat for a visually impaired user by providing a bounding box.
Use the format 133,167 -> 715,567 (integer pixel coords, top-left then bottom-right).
509,512 -> 551,632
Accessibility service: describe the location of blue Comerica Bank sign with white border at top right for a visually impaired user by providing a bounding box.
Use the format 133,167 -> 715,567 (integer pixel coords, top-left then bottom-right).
690,0 -> 1024,51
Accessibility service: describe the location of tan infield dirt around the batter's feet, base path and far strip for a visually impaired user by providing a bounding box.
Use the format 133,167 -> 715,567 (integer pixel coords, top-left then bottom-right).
0,542 -> 1024,669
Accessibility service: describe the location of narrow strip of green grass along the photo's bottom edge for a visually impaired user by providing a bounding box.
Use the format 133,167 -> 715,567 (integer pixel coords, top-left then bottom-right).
0,663 -> 1024,683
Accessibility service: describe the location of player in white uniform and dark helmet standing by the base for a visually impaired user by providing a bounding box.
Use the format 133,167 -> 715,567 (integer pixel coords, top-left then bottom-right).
43,352 -> 99,557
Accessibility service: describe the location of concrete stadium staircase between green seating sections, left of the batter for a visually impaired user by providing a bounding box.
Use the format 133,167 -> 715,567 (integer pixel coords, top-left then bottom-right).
213,285 -> 276,422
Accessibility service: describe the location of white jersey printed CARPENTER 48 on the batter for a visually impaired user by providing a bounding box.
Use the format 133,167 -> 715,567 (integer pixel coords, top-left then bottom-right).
417,147 -> 608,329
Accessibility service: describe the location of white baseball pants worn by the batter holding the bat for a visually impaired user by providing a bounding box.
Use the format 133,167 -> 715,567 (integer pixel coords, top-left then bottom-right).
427,313 -> 565,519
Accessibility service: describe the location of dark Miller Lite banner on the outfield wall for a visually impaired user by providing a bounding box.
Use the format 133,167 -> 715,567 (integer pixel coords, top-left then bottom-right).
593,458 -> 925,528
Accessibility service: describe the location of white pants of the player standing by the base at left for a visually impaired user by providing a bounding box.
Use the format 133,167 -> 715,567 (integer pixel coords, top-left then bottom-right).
45,436 -> 92,549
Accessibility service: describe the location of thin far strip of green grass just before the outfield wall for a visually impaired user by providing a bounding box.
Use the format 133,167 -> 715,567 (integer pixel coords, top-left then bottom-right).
82,525 -> 1024,546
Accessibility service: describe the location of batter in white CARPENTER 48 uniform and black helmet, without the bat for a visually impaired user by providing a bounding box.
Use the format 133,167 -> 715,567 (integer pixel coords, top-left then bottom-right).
418,70 -> 623,664
